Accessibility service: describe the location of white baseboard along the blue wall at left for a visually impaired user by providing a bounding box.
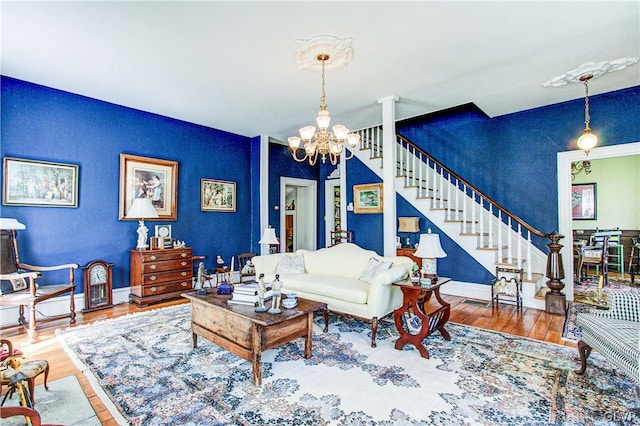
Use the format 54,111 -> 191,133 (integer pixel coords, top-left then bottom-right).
0,287 -> 130,328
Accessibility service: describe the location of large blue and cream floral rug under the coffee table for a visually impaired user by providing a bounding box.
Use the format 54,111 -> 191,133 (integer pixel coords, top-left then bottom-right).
58,305 -> 640,426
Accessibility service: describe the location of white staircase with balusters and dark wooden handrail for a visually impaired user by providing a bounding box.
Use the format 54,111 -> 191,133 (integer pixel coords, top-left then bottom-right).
355,126 -> 548,309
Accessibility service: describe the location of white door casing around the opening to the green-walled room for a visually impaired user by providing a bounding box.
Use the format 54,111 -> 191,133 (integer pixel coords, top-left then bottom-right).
557,142 -> 640,300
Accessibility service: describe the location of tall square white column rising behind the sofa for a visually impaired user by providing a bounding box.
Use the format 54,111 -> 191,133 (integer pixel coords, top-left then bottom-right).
378,95 -> 399,256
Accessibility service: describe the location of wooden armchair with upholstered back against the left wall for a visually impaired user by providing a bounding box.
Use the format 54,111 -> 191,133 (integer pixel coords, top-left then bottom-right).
0,229 -> 78,340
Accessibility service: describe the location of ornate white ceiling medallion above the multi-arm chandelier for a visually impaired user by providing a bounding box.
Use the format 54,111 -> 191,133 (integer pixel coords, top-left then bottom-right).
293,35 -> 353,71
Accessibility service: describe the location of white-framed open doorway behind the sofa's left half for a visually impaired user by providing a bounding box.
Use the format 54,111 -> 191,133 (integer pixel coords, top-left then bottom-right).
280,177 -> 318,253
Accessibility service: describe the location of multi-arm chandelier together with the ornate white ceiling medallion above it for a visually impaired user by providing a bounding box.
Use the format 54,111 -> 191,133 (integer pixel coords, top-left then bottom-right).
287,35 -> 360,166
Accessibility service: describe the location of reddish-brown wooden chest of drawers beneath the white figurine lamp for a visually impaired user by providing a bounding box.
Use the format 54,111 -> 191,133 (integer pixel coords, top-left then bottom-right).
129,247 -> 193,305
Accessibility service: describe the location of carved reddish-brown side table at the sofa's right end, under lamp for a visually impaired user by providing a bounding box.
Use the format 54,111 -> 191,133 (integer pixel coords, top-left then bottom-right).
393,277 -> 451,358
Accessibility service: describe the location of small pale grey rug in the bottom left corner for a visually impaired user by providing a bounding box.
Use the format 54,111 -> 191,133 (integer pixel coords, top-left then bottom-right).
0,376 -> 100,426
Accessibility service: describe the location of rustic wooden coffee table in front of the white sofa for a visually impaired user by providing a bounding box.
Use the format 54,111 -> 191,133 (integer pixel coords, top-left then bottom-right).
182,292 -> 327,386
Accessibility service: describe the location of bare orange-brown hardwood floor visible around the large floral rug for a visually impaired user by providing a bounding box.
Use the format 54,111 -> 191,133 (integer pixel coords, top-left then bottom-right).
2,295 -> 577,425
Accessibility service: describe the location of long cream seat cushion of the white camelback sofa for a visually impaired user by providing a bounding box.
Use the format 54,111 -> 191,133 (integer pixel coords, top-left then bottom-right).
280,274 -> 370,304
